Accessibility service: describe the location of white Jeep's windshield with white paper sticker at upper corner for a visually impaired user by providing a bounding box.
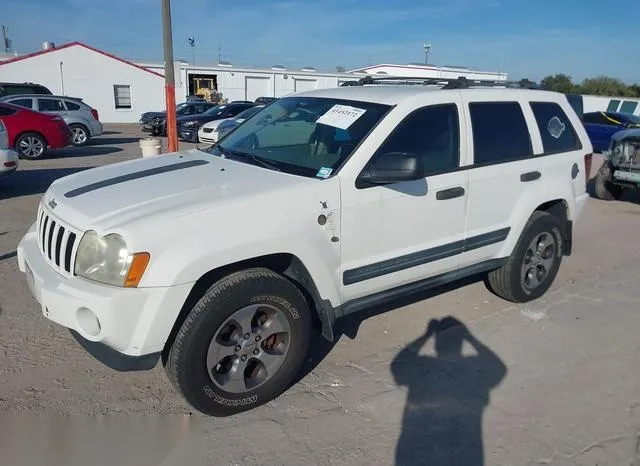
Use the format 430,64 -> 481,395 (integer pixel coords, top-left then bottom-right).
207,96 -> 391,178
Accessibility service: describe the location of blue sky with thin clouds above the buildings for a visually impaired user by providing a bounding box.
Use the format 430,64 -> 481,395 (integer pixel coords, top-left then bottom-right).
0,0 -> 640,83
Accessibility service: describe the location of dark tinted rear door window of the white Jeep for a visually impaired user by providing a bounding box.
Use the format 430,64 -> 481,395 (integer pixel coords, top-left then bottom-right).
469,102 -> 533,165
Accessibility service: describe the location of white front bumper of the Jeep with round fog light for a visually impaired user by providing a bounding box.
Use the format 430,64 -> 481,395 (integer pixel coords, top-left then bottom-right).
17,224 -> 192,370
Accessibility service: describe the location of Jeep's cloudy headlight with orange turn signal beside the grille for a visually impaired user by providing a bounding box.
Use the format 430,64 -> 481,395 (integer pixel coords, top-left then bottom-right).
75,231 -> 149,287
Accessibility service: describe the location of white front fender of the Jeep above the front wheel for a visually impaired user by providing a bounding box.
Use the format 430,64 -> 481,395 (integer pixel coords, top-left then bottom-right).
137,180 -> 340,306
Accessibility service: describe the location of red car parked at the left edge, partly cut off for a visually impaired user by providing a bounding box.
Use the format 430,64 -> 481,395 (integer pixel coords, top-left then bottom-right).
0,103 -> 73,160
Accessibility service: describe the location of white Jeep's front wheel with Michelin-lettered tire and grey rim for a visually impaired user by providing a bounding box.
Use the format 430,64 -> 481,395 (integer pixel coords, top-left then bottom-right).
165,269 -> 311,416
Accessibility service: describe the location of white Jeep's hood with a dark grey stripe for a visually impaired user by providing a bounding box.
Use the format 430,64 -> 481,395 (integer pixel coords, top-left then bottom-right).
43,149 -> 315,234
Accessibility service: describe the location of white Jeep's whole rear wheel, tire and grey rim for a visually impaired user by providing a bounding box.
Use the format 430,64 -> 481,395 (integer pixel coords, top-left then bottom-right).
487,211 -> 563,303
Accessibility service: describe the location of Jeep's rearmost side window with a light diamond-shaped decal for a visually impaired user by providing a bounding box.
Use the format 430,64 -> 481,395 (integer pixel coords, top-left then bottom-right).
530,102 -> 582,154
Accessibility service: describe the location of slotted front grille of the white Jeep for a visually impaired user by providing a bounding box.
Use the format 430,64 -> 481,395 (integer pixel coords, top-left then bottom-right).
38,205 -> 79,277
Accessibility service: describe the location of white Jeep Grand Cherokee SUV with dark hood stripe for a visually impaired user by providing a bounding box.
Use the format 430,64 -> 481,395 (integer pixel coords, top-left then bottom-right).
18,78 -> 592,416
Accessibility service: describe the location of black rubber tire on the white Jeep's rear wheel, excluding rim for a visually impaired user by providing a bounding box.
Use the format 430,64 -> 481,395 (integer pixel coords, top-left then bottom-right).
486,211 -> 563,303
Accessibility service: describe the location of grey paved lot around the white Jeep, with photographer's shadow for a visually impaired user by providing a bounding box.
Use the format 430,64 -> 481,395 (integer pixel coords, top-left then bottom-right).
0,125 -> 640,466
